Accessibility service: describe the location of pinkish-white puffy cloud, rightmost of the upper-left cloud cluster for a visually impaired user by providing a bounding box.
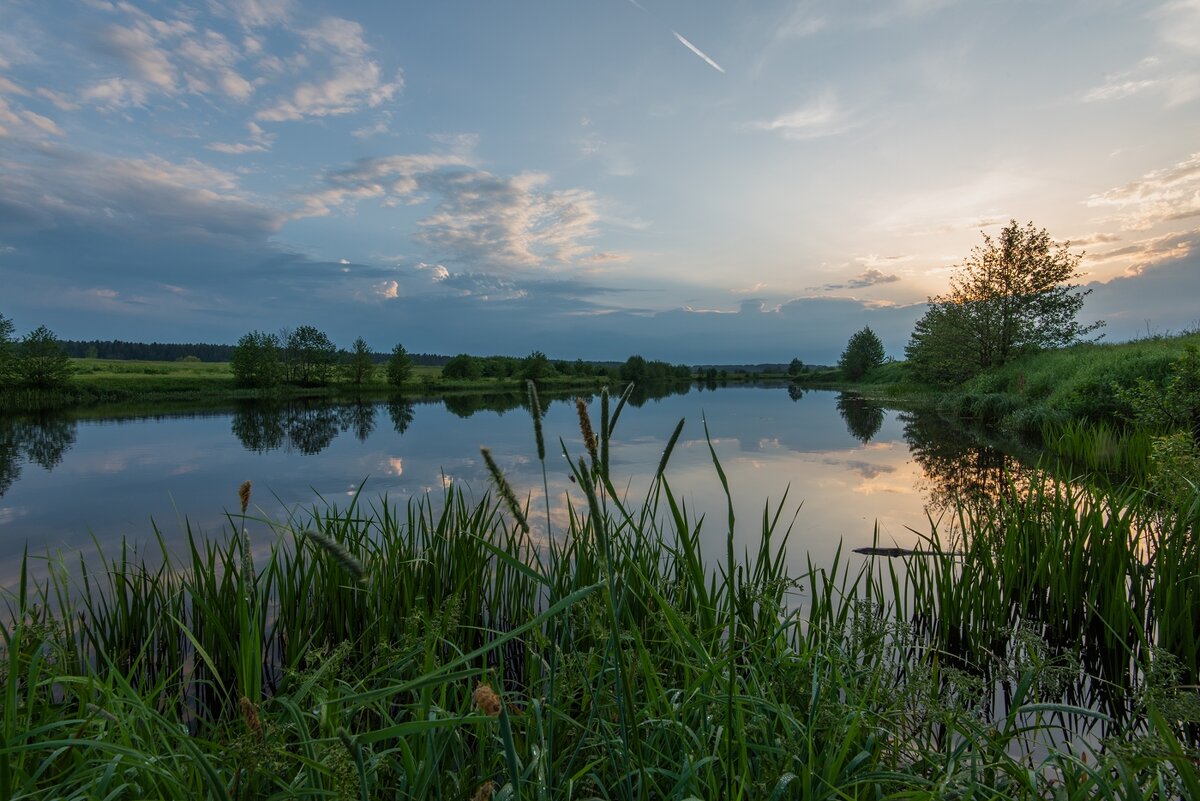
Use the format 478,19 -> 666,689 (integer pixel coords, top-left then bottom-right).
256,17 -> 404,122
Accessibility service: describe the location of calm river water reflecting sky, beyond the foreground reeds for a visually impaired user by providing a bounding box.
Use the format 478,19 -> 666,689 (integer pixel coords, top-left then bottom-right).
0,387 -> 1006,585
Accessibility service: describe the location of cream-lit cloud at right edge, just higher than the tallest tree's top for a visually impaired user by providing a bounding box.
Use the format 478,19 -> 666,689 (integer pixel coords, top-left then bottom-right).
1086,152 -> 1200,230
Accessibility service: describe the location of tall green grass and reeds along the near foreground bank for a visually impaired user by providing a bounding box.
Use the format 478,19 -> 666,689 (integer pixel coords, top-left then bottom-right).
0,389 -> 1200,800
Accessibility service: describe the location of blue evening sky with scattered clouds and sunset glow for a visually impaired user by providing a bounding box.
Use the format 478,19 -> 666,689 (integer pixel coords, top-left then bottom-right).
0,0 -> 1200,363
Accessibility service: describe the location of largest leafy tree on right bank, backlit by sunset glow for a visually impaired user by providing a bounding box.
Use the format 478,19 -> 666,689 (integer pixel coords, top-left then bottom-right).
905,219 -> 1104,384
